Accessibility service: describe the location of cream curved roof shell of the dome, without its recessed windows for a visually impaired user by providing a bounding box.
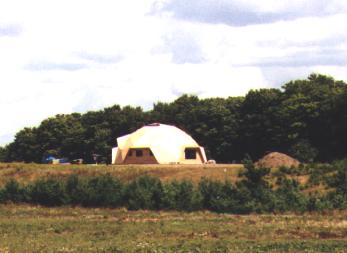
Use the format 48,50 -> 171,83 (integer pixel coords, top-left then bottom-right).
117,123 -> 206,163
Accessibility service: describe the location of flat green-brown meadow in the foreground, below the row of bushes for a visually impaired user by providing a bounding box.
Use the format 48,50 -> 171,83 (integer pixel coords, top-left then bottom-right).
0,204 -> 347,252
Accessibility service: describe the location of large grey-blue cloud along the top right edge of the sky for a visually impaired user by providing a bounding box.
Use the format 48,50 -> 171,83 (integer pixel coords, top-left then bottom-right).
152,0 -> 347,26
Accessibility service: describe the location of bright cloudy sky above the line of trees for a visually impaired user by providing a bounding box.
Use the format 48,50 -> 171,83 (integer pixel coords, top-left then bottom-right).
0,0 -> 347,145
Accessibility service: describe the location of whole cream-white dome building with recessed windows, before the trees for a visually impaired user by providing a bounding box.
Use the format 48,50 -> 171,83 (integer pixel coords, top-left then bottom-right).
112,123 -> 206,164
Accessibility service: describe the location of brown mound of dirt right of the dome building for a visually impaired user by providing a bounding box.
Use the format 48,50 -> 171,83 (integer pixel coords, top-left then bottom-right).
255,152 -> 300,168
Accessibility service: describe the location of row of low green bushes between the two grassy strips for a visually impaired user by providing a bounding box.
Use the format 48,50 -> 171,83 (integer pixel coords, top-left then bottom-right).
0,162 -> 347,214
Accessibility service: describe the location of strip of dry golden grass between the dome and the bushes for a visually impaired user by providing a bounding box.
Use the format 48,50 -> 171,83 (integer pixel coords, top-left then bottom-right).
0,163 -> 243,186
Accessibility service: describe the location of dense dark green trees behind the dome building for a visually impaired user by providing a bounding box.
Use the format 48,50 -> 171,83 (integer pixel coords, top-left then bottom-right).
0,74 -> 347,163
